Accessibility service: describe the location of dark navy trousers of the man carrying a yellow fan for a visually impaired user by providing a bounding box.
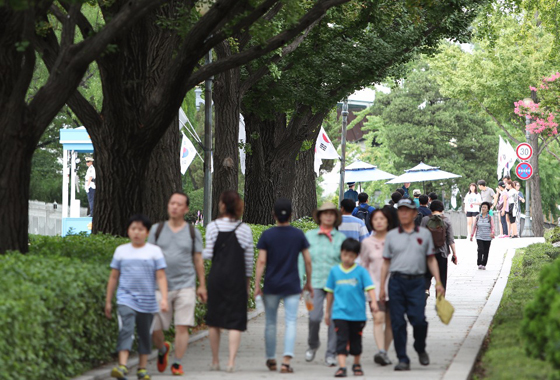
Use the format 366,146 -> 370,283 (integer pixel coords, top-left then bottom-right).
389,276 -> 428,363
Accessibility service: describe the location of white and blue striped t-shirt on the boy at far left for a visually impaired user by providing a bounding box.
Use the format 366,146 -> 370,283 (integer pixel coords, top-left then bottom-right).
111,243 -> 166,313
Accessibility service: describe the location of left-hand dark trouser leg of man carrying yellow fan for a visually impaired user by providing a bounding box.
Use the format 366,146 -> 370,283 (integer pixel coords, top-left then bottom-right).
389,277 -> 410,363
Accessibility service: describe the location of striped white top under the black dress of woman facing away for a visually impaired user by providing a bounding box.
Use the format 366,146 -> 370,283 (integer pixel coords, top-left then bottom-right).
202,218 -> 255,277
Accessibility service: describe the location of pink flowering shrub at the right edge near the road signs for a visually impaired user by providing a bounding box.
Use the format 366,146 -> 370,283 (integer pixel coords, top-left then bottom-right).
514,72 -> 560,137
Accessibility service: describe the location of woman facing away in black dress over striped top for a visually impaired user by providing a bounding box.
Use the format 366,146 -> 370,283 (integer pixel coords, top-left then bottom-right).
203,190 -> 254,372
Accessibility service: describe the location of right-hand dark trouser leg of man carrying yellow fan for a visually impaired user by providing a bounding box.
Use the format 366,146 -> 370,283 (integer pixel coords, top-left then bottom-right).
406,279 -> 428,353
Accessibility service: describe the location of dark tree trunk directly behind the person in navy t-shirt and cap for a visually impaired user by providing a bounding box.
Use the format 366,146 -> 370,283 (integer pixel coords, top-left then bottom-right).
243,113 -> 303,224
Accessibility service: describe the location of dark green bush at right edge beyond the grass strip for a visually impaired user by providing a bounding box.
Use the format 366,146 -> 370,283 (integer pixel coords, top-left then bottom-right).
521,244 -> 560,369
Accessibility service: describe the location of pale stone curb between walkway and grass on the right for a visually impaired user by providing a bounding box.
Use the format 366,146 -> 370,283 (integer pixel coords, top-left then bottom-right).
442,248 -> 515,380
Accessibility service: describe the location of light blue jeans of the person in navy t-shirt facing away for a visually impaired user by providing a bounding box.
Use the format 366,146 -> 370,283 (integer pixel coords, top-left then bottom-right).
263,293 -> 300,359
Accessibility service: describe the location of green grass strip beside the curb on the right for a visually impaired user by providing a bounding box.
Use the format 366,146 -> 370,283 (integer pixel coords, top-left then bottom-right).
472,244 -> 557,380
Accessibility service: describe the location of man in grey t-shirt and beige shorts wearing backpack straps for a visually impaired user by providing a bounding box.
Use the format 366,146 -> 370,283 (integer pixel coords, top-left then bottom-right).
148,192 -> 207,376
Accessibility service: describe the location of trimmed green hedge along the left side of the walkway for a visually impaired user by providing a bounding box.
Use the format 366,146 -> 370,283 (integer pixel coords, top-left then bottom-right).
0,220 -> 316,380
